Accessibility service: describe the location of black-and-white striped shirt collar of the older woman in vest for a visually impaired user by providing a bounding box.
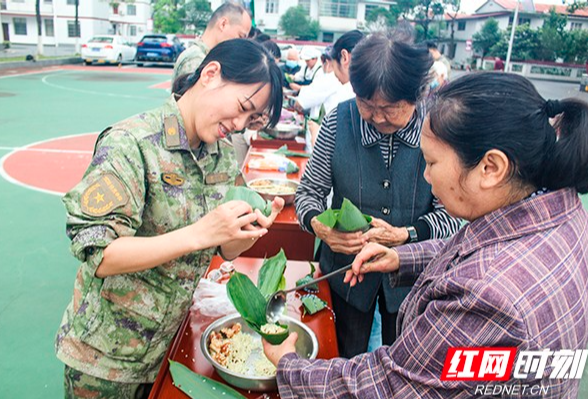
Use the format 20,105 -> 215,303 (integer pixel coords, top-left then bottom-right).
361,102 -> 426,148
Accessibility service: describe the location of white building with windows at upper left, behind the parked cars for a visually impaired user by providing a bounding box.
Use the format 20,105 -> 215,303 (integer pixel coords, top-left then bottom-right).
0,0 -> 151,46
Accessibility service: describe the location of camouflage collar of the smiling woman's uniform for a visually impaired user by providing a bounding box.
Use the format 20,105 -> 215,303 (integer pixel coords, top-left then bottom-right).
162,94 -> 219,155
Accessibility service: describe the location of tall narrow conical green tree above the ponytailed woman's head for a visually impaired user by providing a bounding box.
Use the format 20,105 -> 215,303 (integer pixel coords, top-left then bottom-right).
536,7 -> 568,61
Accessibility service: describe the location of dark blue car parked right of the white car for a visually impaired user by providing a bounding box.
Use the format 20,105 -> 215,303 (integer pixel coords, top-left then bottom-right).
135,34 -> 184,67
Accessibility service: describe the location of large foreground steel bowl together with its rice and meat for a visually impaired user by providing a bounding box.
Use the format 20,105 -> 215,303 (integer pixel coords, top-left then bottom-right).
200,314 -> 318,392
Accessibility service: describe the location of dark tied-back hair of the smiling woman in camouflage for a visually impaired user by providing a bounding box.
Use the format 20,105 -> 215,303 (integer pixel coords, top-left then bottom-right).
173,39 -> 282,126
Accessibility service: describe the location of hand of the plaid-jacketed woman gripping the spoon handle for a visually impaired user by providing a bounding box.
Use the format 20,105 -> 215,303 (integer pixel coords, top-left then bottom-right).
343,243 -> 400,287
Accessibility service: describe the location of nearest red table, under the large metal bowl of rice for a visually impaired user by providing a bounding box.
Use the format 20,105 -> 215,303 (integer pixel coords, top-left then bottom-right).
149,257 -> 339,399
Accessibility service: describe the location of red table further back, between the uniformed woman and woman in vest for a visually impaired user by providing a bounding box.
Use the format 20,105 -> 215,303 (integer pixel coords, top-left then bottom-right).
243,146 -> 314,261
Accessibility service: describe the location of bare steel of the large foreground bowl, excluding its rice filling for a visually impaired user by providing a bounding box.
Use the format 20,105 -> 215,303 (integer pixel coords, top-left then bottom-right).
200,314 -> 318,392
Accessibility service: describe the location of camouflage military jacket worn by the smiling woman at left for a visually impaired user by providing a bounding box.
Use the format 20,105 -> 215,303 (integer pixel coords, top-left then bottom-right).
55,94 -> 239,394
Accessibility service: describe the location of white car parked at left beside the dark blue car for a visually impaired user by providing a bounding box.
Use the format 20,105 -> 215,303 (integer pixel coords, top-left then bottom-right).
82,35 -> 137,65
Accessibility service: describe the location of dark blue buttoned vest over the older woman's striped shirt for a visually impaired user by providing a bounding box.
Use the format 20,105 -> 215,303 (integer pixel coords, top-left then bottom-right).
320,99 -> 433,313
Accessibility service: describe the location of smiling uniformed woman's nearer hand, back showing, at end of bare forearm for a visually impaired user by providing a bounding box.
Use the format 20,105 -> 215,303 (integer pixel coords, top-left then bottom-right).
191,201 -> 266,249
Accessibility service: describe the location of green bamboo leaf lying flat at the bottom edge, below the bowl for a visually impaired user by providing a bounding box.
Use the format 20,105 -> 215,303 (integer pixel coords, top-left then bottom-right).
169,360 -> 246,399
